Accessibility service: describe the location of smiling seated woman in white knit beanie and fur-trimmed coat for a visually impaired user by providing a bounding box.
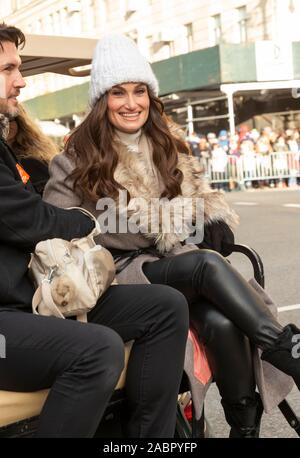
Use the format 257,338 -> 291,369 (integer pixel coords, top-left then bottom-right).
45,36 -> 300,437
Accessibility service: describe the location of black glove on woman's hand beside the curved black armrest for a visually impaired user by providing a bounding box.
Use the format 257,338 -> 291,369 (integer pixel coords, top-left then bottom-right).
198,220 -> 234,256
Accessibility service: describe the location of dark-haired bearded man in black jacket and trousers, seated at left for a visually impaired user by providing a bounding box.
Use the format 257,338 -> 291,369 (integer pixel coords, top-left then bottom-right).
0,24 -> 188,437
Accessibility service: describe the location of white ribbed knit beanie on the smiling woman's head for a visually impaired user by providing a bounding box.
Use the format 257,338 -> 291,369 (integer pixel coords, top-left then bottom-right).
90,35 -> 158,107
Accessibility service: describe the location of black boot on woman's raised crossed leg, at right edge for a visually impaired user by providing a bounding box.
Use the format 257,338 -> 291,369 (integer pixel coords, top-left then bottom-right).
261,324 -> 300,390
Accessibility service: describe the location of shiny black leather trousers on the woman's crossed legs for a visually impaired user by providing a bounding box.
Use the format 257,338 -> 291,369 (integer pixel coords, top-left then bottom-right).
143,250 -> 282,404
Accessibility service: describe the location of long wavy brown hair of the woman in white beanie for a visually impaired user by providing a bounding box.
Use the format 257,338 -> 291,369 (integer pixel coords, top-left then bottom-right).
65,88 -> 189,202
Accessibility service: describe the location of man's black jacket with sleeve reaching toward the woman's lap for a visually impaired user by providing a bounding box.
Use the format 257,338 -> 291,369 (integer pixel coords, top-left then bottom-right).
0,138 -> 94,311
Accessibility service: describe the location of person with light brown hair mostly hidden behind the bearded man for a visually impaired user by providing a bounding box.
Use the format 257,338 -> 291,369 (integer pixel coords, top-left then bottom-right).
6,105 -> 58,195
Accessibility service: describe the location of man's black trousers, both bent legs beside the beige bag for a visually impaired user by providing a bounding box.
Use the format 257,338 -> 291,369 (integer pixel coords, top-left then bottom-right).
0,285 -> 188,437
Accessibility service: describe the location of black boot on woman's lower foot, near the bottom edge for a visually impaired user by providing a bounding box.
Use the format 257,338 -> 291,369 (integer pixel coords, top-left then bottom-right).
221,393 -> 264,439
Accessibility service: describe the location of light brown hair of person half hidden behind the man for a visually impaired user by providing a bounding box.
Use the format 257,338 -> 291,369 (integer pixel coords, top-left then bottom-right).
7,105 -> 58,162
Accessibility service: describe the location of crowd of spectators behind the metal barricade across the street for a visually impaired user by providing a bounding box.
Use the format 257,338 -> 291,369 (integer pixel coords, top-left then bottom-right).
186,125 -> 300,187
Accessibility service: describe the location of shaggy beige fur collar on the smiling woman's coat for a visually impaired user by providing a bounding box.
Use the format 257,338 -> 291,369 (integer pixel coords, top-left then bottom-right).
115,135 -> 238,252
